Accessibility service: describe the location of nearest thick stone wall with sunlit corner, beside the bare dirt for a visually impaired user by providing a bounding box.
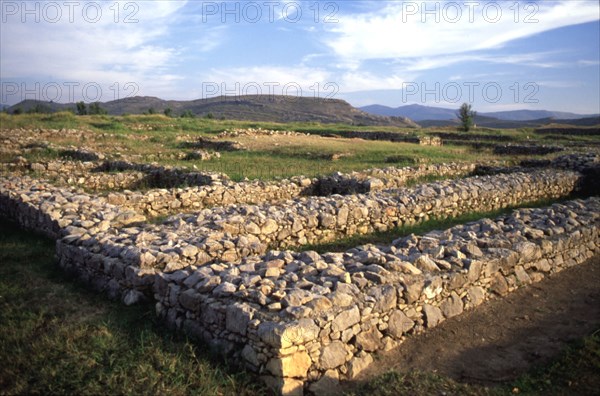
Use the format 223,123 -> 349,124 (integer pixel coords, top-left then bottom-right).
154,198 -> 600,394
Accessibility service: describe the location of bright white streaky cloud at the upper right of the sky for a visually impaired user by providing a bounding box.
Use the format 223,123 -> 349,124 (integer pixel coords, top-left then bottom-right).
324,1 -> 600,62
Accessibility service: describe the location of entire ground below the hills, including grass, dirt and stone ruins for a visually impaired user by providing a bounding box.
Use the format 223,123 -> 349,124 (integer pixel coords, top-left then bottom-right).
0,113 -> 600,395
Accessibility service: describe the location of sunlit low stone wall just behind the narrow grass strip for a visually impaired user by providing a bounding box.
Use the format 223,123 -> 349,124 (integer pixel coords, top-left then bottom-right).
59,171 -> 579,287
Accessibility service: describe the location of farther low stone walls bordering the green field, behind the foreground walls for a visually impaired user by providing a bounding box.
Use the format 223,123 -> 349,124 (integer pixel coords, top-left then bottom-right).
6,161 -> 476,216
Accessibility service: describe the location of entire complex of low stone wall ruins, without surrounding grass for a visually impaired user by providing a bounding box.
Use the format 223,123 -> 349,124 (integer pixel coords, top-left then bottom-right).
0,130 -> 600,395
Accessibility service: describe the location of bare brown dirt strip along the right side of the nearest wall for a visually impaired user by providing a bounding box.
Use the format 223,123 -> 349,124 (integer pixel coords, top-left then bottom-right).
343,257 -> 600,389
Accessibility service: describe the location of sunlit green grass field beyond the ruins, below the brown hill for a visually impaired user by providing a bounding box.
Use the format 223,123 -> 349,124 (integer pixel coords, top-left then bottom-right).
0,113 -> 586,180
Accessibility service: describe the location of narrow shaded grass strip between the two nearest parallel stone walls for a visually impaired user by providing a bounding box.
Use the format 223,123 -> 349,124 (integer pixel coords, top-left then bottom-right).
300,196 -> 576,253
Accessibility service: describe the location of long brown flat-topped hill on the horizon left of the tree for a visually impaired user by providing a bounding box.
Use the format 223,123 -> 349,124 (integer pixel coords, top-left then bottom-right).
8,95 -> 418,127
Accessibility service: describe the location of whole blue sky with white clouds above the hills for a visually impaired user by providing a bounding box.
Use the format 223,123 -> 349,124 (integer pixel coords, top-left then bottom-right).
0,0 -> 600,114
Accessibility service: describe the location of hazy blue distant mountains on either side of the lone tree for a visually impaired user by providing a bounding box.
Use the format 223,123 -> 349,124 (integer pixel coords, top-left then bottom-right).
360,105 -> 598,122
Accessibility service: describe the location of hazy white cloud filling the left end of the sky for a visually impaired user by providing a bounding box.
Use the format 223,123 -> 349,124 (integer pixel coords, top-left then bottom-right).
0,1 -> 186,100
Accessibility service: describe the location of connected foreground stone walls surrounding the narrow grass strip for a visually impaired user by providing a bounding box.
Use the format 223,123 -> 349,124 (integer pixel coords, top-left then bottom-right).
0,152 -> 600,394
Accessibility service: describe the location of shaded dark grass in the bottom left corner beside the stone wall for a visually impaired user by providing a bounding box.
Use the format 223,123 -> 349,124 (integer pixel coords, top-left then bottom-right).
0,221 -> 265,395
